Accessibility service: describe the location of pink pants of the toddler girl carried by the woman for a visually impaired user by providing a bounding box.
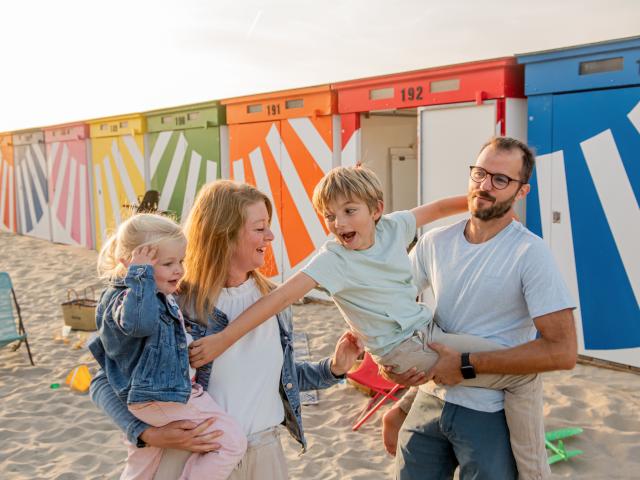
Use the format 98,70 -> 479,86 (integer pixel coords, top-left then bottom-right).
120,384 -> 247,480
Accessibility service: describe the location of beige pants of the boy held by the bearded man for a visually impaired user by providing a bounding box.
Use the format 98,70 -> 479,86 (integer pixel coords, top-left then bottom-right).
373,322 -> 551,480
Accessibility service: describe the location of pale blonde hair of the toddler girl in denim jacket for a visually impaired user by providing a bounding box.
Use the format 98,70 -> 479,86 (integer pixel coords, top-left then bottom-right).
98,213 -> 185,279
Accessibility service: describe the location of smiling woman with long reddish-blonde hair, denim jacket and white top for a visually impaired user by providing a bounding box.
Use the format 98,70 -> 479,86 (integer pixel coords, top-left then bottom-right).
91,180 -> 362,480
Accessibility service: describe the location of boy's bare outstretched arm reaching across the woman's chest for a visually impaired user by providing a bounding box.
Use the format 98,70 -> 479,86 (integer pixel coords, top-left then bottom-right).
189,272 -> 317,368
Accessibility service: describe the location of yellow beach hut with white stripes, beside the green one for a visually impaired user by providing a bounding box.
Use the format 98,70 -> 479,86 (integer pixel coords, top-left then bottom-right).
88,114 -> 149,250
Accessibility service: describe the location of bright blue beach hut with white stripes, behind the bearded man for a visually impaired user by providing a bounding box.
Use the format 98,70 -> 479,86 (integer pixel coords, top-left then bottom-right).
518,37 -> 640,367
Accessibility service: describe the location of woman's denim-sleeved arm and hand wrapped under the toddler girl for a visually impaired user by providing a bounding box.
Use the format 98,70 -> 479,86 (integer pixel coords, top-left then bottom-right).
89,370 -> 222,453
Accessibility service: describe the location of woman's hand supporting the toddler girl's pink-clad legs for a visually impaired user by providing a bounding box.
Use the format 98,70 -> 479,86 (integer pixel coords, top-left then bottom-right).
140,418 -> 222,453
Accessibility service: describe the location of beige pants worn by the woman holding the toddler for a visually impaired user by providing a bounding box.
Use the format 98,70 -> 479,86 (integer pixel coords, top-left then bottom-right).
154,428 -> 289,480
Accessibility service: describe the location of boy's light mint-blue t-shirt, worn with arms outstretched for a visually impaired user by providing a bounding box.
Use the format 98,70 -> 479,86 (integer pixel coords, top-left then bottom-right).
302,211 -> 433,355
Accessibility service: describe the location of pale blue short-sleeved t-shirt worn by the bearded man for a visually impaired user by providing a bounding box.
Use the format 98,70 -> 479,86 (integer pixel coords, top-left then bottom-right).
411,220 -> 575,412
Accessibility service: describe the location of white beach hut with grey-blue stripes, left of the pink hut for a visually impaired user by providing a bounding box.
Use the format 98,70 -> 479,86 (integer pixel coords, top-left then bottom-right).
13,129 -> 51,240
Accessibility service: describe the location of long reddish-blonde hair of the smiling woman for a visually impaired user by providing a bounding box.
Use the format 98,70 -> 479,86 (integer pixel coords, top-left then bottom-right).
180,180 -> 273,323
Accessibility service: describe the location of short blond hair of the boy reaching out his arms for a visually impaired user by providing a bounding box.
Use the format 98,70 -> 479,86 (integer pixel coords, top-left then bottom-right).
312,165 -> 383,214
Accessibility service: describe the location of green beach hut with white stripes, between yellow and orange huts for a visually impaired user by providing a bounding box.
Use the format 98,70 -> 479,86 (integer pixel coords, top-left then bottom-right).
145,102 -> 228,221
